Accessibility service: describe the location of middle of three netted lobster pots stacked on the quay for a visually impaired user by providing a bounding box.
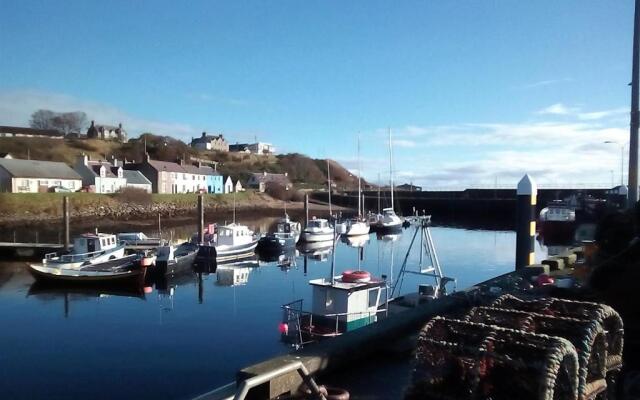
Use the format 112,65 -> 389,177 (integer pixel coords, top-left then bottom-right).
466,307 -> 607,398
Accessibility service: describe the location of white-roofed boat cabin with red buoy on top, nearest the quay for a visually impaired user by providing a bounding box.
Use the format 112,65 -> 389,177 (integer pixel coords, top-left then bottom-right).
309,272 -> 386,334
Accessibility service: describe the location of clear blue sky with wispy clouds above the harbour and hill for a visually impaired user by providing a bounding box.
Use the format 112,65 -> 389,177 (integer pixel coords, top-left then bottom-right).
0,0 -> 633,188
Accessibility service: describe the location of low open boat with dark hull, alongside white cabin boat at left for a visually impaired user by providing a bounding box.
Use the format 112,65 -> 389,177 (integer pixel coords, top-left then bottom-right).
28,254 -> 146,284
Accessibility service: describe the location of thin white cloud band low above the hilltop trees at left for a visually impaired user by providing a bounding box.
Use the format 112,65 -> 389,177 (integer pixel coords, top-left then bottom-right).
0,90 -> 198,140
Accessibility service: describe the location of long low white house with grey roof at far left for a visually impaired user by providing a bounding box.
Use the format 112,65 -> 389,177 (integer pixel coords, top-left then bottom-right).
0,158 -> 82,193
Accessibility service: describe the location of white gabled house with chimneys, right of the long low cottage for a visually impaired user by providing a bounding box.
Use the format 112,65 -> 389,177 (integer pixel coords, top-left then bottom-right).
73,154 -> 127,193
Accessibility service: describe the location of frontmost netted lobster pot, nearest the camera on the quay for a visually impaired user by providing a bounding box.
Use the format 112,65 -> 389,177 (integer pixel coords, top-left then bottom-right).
405,317 -> 578,400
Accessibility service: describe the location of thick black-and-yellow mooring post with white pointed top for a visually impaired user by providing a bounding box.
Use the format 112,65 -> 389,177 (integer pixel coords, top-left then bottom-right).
516,174 -> 538,270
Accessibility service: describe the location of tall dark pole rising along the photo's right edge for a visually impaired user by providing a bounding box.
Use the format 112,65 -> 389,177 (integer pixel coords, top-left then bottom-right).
627,0 -> 640,208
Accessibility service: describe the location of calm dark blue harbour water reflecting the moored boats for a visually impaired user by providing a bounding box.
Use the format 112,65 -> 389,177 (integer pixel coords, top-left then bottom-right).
0,219 -> 546,399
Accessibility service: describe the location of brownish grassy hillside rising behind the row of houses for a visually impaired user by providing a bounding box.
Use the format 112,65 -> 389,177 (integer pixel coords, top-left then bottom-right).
0,134 -> 357,188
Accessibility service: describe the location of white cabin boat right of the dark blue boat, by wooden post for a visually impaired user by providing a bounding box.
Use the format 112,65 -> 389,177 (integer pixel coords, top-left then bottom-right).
204,223 -> 258,262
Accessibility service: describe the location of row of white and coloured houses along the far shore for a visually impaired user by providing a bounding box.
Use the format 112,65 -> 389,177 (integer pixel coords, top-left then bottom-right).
0,154 -> 292,194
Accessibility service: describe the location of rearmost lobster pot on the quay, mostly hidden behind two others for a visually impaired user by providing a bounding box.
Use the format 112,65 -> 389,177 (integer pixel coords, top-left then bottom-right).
492,294 -> 624,371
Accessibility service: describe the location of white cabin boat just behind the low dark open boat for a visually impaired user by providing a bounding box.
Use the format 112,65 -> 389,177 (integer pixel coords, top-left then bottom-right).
42,232 -> 125,270
